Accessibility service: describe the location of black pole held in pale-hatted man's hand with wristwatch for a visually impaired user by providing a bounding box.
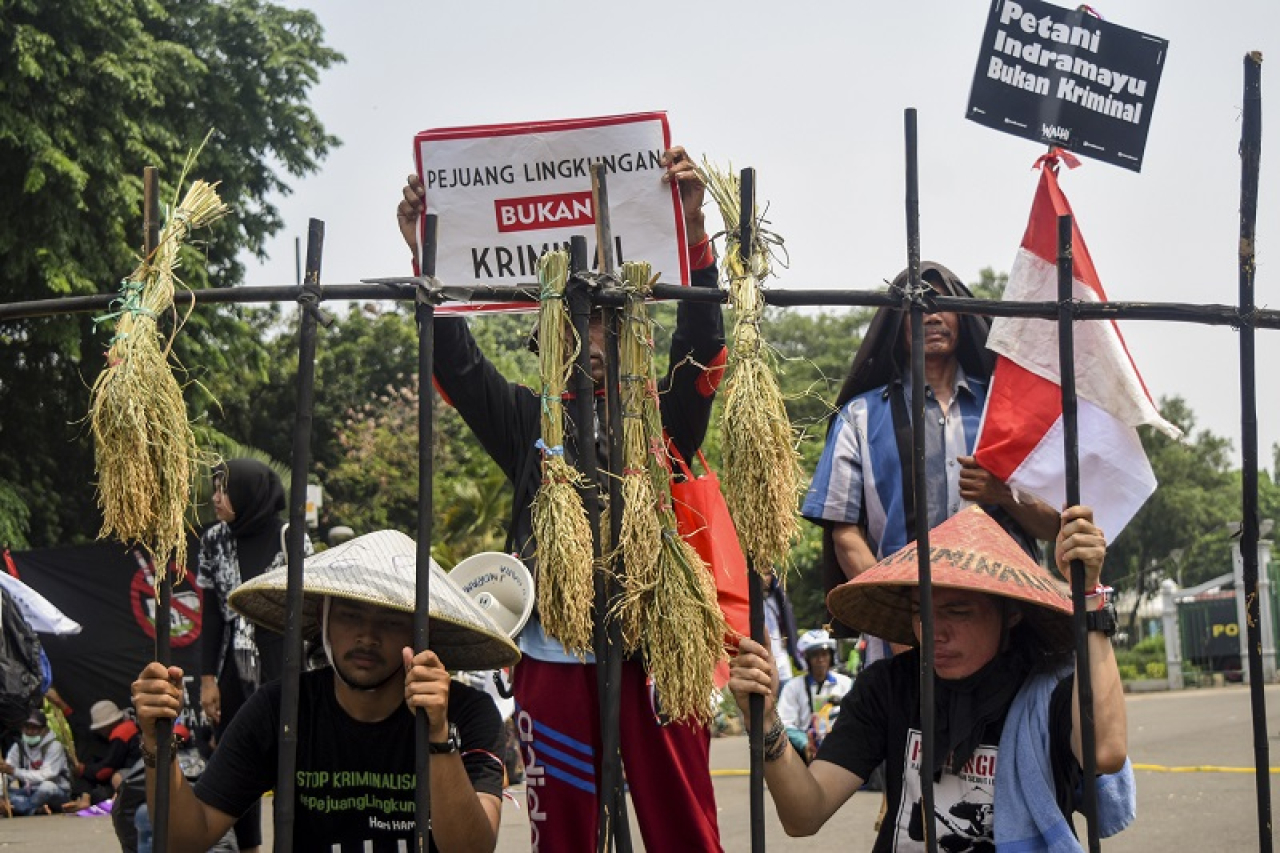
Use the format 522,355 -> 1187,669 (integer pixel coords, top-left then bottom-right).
413,208 -> 436,853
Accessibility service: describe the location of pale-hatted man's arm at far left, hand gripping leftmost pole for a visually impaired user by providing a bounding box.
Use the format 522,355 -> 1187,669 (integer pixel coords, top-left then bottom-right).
133,662 -> 236,853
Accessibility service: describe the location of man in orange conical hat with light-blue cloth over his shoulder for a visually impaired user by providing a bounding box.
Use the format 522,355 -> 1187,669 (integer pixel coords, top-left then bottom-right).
730,507 -> 1134,852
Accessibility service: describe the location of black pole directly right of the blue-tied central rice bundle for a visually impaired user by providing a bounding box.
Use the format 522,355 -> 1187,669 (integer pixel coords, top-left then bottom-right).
564,236 -> 621,852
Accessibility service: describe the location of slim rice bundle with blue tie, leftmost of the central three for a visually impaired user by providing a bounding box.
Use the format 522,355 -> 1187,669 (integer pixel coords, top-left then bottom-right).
532,251 -> 595,654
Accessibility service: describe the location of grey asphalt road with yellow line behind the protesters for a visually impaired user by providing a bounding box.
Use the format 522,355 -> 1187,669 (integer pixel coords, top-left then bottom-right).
0,685 -> 1280,853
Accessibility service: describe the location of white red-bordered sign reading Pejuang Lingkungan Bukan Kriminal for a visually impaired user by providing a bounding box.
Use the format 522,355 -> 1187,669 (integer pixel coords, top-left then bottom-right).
415,113 -> 689,310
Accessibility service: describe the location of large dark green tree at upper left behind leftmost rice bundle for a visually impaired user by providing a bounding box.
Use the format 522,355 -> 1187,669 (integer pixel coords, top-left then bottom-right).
0,0 -> 342,544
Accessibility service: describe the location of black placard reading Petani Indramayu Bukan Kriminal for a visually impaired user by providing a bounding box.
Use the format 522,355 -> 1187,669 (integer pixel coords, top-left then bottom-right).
968,0 -> 1169,172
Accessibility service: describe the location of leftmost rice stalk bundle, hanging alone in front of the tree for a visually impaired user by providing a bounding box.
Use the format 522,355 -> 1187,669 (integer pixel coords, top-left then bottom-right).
90,175 -> 228,584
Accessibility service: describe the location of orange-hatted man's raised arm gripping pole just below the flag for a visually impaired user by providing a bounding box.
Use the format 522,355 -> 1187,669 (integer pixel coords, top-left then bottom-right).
1053,506 -> 1129,774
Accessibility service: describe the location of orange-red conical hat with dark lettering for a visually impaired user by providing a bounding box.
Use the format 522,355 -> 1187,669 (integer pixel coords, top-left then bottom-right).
827,506 -> 1073,652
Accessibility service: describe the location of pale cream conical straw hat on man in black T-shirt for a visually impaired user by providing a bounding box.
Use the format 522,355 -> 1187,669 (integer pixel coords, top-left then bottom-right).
230,530 -> 520,670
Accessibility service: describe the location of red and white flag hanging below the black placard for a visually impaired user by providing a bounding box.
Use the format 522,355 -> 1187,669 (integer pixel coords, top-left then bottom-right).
974,152 -> 1181,540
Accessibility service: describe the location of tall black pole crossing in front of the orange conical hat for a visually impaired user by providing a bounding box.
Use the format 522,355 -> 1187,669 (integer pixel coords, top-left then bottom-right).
902,109 -> 938,853
